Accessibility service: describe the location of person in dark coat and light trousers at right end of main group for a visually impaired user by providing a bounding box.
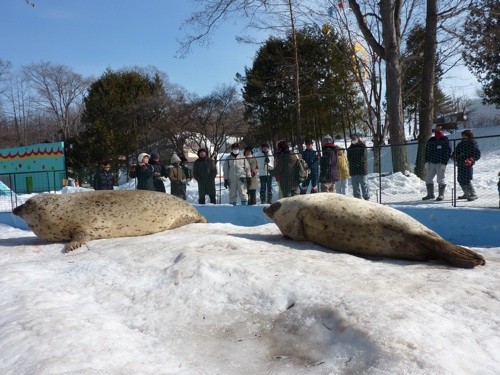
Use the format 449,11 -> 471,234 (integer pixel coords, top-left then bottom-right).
347,134 -> 370,200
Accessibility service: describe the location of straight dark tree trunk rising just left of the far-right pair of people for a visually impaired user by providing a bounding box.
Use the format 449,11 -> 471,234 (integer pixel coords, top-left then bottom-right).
415,0 -> 437,179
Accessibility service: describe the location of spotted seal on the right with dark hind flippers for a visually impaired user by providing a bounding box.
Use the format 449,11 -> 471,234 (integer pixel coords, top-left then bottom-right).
264,193 -> 485,268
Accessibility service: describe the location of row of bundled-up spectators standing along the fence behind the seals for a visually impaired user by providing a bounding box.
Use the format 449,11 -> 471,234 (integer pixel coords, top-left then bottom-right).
94,127 -> 481,205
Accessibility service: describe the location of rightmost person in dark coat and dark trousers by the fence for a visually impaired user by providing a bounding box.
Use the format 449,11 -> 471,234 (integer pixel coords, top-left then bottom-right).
452,130 -> 481,201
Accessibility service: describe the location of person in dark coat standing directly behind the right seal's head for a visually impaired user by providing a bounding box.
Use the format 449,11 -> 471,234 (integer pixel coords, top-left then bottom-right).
274,140 -> 299,197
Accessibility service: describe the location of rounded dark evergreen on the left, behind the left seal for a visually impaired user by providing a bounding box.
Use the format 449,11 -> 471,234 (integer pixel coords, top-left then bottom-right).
75,69 -> 163,165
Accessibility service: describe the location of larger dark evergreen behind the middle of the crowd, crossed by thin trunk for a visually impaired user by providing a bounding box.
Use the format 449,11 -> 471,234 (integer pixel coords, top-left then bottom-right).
239,28 -> 359,146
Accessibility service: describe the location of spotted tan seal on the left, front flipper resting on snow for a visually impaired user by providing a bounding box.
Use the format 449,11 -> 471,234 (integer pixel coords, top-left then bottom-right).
13,190 -> 207,251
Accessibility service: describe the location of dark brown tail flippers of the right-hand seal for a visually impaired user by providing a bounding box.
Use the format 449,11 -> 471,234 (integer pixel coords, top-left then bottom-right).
426,238 -> 486,268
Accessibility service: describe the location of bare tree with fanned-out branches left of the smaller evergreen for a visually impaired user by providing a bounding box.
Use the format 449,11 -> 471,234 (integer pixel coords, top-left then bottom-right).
22,62 -> 90,140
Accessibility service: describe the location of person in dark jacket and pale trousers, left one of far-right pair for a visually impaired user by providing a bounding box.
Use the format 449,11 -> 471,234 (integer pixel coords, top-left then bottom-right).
422,126 -> 451,201
